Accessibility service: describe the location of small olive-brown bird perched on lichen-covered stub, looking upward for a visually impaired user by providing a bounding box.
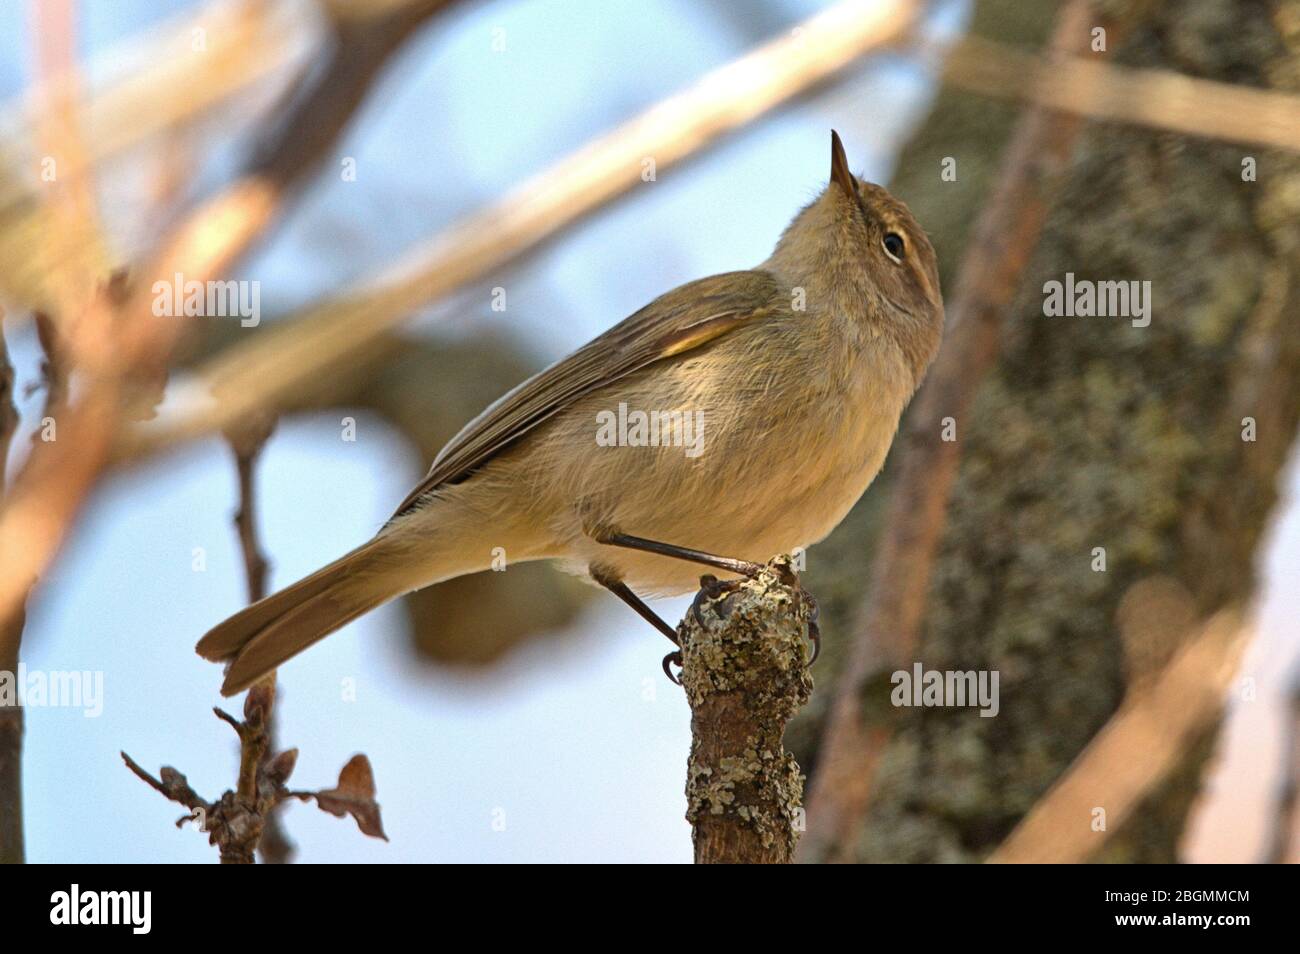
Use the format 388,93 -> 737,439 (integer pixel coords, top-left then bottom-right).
198,133 -> 944,695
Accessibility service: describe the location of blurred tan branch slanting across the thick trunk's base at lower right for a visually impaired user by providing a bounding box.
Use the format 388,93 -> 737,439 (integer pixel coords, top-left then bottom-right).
988,612 -> 1249,864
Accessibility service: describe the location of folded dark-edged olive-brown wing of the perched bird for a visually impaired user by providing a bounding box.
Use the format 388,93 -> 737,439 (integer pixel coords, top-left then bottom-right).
393,272 -> 783,517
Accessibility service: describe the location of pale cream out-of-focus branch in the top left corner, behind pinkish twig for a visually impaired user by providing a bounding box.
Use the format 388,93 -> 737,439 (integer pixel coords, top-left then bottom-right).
0,0 -> 303,311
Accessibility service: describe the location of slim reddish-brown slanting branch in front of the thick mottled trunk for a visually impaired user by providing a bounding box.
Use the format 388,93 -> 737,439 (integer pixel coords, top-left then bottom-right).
801,0 -> 1107,860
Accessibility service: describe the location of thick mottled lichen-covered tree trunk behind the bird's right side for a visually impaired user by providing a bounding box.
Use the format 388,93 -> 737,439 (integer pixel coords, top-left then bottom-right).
801,0 -> 1300,862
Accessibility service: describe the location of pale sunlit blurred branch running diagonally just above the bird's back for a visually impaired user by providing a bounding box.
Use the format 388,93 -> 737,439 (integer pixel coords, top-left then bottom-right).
118,0 -> 918,458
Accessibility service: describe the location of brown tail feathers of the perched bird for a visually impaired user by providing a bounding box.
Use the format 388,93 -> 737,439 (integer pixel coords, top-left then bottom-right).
195,535 -> 413,695
